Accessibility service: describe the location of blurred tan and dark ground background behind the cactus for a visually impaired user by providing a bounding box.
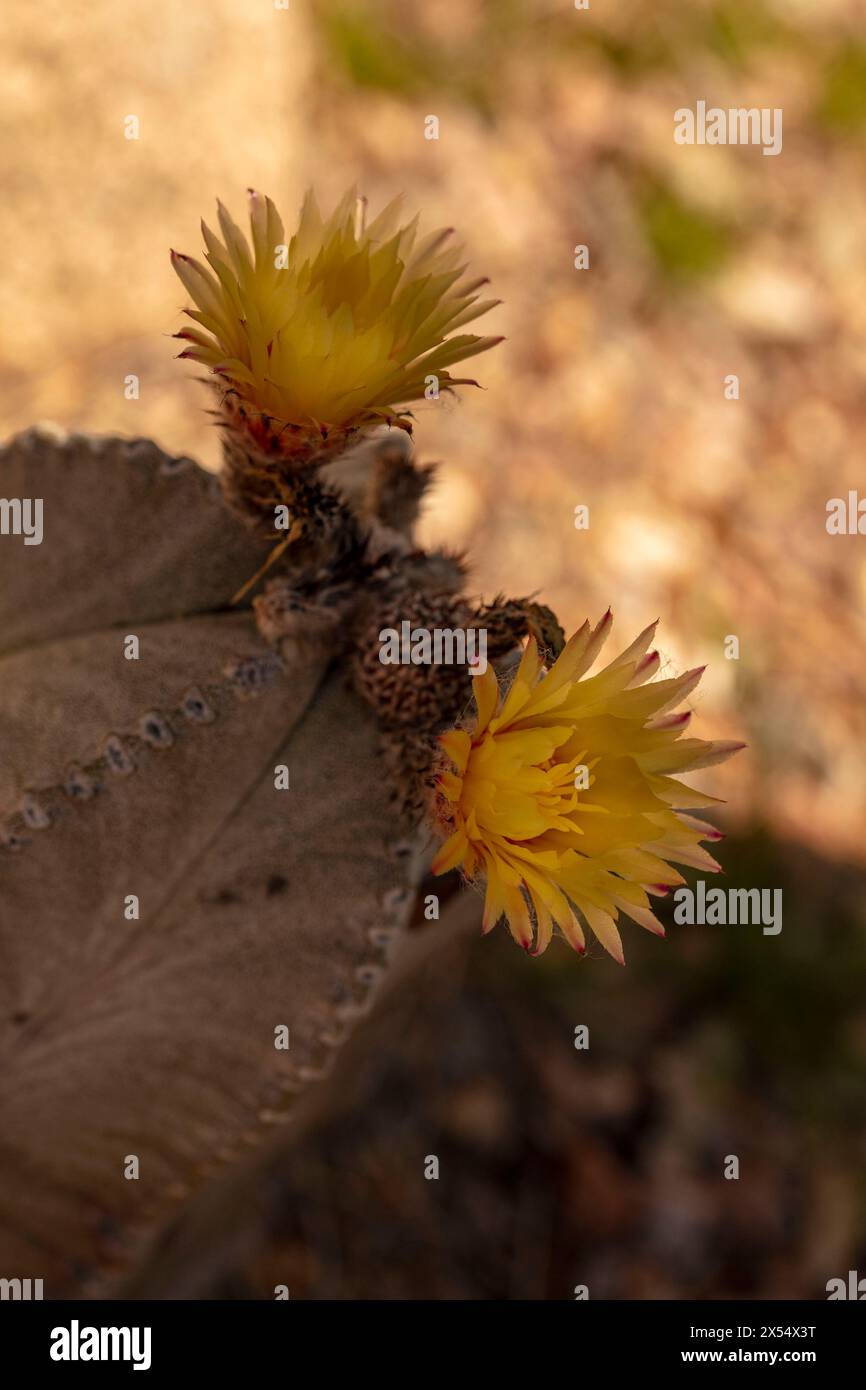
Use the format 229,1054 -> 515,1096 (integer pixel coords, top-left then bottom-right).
0,0 -> 866,1298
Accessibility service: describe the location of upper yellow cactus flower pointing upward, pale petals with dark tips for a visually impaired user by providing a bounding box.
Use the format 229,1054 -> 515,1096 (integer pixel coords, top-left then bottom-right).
171,189 -> 502,456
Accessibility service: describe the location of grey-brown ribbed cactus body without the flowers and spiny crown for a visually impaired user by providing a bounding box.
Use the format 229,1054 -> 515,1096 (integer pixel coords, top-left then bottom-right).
0,436 -> 430,1295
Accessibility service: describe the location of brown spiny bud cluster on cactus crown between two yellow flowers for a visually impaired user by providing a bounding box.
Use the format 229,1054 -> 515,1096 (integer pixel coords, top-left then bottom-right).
237,430 -> 563,821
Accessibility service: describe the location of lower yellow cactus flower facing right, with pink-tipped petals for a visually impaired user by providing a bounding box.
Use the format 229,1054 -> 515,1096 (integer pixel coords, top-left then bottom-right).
434,612 -> 744,965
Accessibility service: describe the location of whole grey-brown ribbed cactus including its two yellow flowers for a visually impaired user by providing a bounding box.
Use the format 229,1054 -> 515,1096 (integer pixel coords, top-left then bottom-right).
0,196 -> 730,1297
